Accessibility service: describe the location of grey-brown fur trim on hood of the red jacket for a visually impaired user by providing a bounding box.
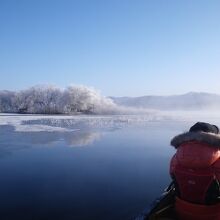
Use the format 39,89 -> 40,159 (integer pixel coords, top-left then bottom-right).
170,131 -> 220,148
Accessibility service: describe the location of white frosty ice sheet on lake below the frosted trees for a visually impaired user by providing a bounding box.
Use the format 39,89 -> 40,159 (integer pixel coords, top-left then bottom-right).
0,114 -> 166,132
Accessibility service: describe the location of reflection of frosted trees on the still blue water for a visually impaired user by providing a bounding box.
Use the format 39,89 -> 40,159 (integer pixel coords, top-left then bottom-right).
0,125 -> 101,158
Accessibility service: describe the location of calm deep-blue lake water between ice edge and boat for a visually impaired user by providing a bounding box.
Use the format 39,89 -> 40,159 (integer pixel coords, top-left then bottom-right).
0,118 -> 200,220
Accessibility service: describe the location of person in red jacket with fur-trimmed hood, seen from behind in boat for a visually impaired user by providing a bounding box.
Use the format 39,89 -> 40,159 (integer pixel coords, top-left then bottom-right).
170,122 -> 220,220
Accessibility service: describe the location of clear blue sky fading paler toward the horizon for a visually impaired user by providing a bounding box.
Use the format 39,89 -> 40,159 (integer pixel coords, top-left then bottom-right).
0,0 -> 220,96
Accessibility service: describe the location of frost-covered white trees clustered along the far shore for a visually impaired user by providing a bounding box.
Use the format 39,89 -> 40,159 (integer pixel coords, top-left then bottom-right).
0,86 -> 116,114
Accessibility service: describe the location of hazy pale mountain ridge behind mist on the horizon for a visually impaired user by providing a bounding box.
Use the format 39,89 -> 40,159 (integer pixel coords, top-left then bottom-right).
110,92 -> 220,110
